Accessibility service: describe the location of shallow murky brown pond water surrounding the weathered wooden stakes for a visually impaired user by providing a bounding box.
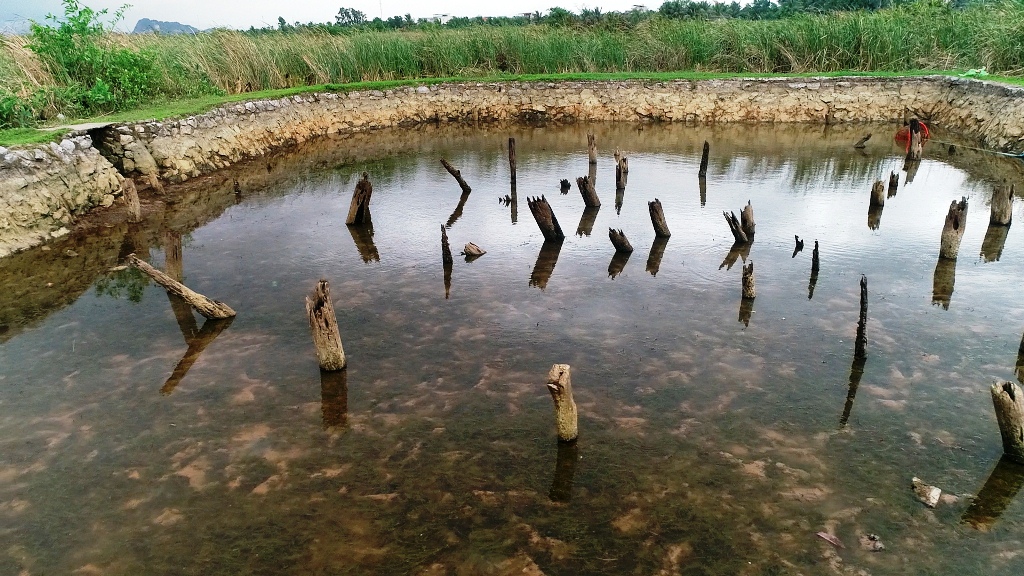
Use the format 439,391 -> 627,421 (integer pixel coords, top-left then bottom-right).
0,125 -> 1024,574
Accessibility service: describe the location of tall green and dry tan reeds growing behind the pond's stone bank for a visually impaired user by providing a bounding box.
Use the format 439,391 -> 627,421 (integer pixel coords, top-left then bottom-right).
0,0 -> 1024,127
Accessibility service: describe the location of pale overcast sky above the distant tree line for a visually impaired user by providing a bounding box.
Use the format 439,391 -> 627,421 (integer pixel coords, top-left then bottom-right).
0,0 -> 662,31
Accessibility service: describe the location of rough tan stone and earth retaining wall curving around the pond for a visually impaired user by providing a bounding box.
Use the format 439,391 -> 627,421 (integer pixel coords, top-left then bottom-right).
0,76 -> 1024,256
